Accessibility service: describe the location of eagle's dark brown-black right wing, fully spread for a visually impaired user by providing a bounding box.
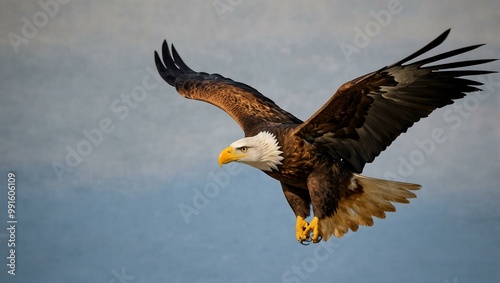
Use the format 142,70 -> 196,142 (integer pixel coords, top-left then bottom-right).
294,30 -> 494,173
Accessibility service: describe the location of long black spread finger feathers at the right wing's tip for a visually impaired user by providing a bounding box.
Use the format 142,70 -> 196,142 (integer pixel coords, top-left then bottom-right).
381,29 -> 498,74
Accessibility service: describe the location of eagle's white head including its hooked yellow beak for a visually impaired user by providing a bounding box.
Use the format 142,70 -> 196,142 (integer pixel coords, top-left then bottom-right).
219,132 -> 283,171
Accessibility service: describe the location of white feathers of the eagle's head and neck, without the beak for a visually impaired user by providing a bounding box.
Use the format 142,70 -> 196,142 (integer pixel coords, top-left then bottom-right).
231,132 -> 284,171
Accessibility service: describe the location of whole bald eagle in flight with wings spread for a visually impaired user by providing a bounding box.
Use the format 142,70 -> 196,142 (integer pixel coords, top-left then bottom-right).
154,30 -> 495,244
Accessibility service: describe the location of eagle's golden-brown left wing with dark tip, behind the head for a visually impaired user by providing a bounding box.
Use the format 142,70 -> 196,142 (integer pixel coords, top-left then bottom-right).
155,41 -> 302,136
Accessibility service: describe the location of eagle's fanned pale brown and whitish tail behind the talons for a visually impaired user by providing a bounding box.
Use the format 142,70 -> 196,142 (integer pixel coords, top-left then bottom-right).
321,174 -> 420,241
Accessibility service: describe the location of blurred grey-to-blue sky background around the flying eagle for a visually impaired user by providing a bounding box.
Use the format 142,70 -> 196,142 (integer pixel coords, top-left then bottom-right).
0,0 -> 500,283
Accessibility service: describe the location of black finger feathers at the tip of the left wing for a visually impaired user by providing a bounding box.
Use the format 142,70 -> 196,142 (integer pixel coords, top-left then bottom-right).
155,40 -> 196,86
